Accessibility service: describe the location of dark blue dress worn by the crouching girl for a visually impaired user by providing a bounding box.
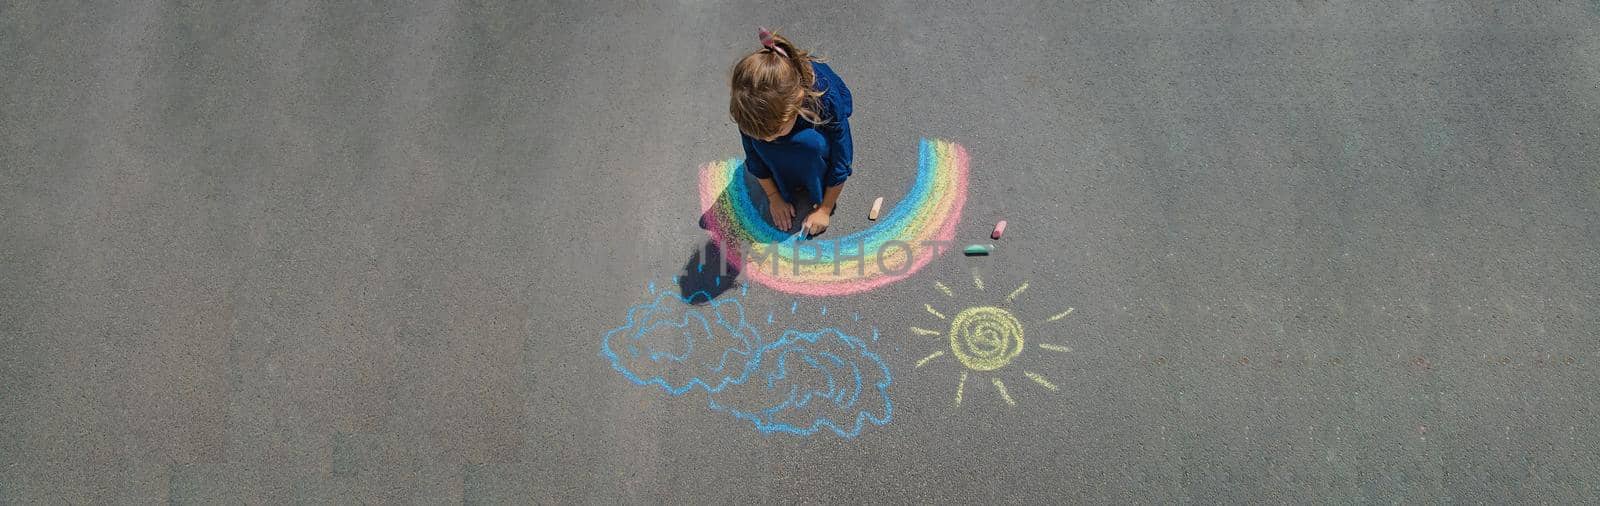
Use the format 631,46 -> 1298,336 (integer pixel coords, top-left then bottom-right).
739,62 -> 854,208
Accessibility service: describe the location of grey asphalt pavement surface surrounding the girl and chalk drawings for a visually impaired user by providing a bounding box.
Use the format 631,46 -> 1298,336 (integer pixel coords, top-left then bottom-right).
0,0 -> 1600,503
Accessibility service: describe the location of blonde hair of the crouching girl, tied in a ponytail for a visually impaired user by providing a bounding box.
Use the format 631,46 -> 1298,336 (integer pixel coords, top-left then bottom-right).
728,34 -> 824,139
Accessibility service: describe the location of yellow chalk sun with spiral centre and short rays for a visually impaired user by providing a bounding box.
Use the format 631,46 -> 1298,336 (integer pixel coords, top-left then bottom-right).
910,274 -> 1072,407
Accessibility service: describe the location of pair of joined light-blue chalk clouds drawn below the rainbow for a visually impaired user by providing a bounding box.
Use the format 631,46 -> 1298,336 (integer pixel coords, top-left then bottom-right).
600,290 -> 893,439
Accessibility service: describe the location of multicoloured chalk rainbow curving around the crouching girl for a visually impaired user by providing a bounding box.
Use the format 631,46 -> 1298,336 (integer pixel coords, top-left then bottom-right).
699,139 -> 968,296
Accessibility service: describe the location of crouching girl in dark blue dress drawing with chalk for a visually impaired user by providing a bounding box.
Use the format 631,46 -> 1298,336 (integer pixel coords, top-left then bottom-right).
728,29 -> 853,235
